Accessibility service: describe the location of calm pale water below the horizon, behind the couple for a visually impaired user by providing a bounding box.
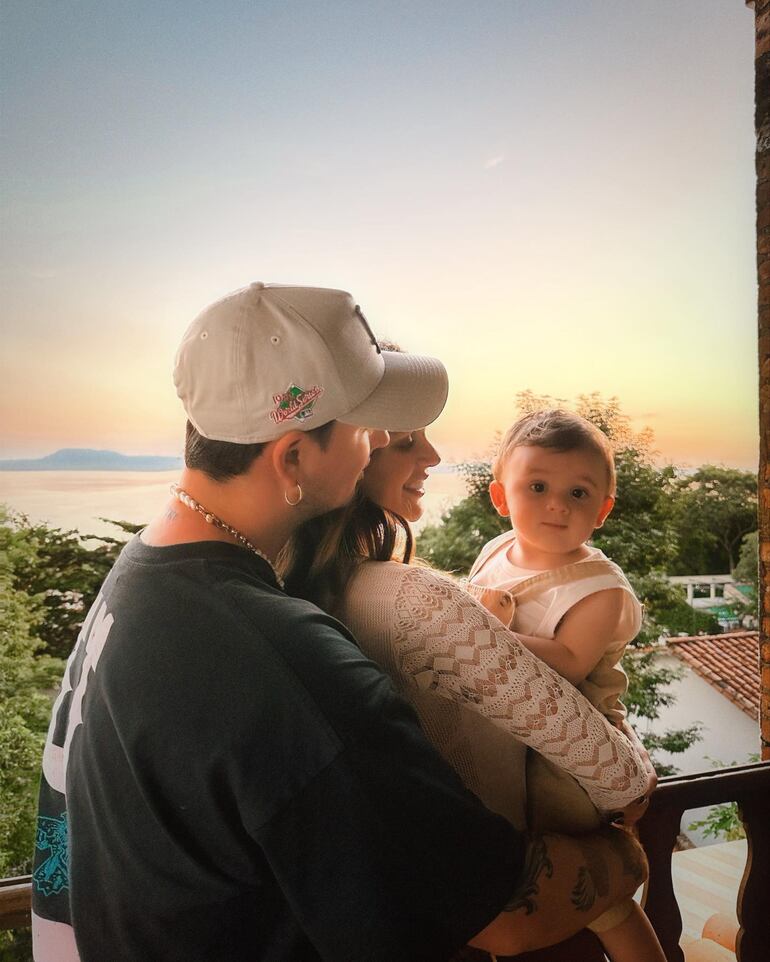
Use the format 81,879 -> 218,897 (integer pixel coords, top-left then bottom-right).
0,471 -> 465,535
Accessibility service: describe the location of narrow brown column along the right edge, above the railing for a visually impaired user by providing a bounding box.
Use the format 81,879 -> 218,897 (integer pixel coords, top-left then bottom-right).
749,0 -> 770,759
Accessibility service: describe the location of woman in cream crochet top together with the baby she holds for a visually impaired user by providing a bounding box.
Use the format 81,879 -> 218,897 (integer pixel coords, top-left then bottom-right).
285,356 -> 665,962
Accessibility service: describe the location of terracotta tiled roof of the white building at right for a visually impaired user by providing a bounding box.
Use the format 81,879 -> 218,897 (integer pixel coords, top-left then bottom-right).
667,631 -> 759,719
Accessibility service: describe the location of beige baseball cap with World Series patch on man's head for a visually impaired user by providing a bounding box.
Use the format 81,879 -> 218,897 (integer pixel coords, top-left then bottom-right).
174,283 -> 448,444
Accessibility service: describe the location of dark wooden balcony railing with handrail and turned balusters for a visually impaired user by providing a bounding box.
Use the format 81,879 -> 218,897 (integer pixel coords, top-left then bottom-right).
0,762 -> 770,962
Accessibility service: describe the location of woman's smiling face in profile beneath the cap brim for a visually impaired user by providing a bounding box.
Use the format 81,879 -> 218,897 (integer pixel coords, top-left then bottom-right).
361,430 -> 441,521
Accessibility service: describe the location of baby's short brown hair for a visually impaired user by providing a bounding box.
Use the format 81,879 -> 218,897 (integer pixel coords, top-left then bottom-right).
492,408 -> 617,497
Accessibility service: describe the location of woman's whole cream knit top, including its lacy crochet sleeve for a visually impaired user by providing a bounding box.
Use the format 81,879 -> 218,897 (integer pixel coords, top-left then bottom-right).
340,561 -> 647,827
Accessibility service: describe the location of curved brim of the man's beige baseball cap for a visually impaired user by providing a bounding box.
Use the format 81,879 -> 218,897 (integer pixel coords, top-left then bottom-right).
337,351 -> 449,431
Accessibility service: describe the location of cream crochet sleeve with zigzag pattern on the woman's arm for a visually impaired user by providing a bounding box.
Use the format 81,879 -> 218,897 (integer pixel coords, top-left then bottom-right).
394,565 -> 647,811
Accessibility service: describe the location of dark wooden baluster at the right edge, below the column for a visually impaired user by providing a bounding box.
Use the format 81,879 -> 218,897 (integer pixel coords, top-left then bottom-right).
736,792 -> 770,962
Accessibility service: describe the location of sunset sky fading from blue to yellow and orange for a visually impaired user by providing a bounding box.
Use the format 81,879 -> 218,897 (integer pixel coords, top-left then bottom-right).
0,0 -> 757,468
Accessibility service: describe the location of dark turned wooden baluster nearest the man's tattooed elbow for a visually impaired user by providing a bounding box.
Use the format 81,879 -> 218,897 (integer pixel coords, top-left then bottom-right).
639,795 -> 684,962
